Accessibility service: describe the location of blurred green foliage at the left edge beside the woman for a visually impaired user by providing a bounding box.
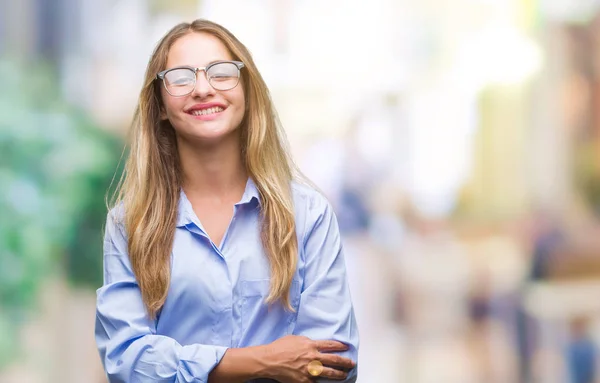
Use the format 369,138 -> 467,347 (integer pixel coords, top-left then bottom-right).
0,60 -> 123,367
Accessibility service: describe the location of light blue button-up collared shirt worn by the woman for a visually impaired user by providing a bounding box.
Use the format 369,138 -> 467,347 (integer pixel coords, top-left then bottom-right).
96,179 -> 358,383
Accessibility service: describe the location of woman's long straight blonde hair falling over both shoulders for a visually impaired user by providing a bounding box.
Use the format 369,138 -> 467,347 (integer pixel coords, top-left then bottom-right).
113,19 -> 298,318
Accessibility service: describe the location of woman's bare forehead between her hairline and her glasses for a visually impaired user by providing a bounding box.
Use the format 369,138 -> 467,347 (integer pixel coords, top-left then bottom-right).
166,32 -> 232,68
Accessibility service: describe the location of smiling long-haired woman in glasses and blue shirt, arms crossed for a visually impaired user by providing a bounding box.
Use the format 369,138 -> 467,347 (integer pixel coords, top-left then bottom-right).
96,20 -> 358,383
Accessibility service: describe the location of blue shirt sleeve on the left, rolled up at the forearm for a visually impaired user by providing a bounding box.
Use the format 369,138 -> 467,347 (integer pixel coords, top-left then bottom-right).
95,211 -> 227,383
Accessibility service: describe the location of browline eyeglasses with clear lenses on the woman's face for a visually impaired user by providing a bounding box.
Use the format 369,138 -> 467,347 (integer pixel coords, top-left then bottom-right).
156,61 -> 244,97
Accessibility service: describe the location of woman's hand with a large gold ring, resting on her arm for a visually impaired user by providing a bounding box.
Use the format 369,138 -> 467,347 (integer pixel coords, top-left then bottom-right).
264,335 -> 355,383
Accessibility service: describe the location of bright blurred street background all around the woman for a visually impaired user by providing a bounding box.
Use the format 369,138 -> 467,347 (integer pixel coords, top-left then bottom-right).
0,0 -> 600,383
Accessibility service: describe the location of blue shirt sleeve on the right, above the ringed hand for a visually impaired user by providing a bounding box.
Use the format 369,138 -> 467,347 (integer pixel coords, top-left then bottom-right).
294,196 -> 359,383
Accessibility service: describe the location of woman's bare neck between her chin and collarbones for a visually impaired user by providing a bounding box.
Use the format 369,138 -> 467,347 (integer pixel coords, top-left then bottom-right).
177,135 -> 248,202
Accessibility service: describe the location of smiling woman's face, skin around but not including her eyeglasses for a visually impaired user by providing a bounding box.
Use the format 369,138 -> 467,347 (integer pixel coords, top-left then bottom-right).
161,32 -> 245,143
